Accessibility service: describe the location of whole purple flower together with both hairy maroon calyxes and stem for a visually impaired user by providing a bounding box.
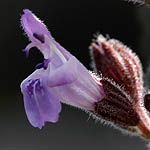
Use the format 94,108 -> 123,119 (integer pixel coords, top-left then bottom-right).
21,10 -> 150,138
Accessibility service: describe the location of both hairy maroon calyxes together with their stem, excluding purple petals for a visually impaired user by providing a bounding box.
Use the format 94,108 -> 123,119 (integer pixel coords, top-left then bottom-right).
91,35 -> 150,138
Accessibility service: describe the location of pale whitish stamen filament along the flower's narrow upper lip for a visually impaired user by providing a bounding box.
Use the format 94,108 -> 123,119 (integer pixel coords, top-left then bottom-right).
44,35 -> 67,63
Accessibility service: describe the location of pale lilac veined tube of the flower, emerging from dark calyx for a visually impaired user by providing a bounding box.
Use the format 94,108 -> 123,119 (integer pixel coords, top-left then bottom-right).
48,57 -> 104,110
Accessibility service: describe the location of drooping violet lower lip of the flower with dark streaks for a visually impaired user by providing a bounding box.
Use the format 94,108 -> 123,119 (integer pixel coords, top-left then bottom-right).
21,73 -> 61,128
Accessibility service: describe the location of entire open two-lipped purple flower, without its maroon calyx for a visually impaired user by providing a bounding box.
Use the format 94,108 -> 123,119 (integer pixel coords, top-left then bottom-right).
21,10 -> 104,128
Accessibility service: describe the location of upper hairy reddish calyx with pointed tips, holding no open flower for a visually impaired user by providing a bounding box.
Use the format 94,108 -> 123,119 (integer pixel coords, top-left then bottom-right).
91,37 -> 143,101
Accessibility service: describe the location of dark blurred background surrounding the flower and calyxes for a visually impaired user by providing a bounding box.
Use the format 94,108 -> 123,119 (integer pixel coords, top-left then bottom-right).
0,0 -> 150,150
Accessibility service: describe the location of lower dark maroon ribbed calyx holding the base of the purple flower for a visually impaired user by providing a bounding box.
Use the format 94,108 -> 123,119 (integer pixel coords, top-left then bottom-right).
95,79 -> 140,127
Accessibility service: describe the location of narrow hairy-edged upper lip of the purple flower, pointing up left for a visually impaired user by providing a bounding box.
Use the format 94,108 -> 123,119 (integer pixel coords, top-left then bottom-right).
21,9 -> 71,59
